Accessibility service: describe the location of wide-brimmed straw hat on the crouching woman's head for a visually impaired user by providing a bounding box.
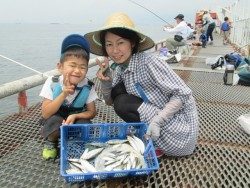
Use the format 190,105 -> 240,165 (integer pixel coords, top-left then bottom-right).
84,12 -> 155,55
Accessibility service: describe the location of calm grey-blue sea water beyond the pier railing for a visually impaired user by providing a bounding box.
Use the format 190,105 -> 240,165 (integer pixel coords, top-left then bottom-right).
0,23 -> 167,117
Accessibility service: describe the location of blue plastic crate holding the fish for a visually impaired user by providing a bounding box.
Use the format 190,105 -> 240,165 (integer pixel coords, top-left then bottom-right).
60,123 -> 159,182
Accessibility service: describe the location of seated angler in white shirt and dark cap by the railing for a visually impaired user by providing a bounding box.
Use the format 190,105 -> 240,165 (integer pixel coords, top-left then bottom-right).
163,14 -> 190,52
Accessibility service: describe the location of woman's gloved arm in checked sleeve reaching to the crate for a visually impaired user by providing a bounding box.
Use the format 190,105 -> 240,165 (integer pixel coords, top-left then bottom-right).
147,55 -> 192,139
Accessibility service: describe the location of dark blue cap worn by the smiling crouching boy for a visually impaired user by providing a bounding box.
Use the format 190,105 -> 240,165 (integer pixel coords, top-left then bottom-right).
61,34 -> 90,55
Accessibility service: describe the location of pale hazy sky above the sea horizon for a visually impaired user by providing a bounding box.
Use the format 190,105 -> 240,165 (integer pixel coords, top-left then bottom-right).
0,0 -> 236,24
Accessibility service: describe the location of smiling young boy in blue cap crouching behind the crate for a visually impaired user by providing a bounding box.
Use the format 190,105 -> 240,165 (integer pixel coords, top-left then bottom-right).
40,34 -> 97,159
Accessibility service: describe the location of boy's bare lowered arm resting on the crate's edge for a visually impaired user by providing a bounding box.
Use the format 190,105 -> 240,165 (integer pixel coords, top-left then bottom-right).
63,101 -> 96,124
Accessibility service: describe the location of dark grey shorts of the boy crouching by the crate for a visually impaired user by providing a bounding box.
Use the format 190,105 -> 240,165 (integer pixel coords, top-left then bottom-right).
40,115 -> 91,139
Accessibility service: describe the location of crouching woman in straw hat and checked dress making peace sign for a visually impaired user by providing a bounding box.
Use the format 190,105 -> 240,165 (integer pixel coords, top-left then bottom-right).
85,13 -> 198,156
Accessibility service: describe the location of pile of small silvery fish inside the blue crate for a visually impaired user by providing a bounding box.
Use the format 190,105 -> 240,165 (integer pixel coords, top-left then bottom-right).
66,135 -> 146,174
